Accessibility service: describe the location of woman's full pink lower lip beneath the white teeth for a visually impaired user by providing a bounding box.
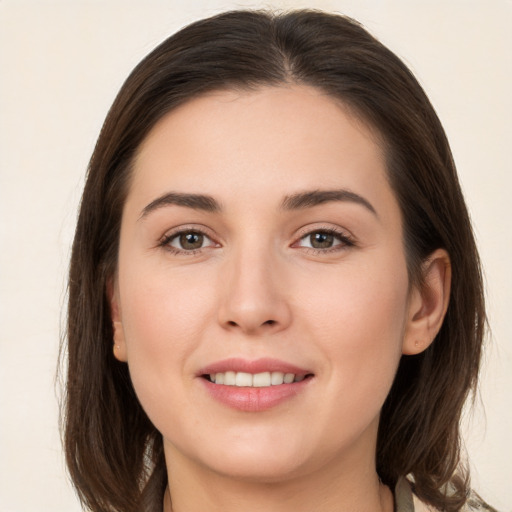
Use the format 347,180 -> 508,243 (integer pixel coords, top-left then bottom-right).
201,377 -> 312,412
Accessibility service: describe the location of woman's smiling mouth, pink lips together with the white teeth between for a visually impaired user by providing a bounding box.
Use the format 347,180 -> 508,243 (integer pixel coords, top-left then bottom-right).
198,358 -> 314,412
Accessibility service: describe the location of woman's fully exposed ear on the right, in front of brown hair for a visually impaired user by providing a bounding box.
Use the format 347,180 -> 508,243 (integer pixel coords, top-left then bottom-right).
402,249 -> 452,355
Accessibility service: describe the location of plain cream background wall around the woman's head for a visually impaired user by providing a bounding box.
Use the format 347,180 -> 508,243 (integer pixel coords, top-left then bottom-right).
0,0 -> 512,512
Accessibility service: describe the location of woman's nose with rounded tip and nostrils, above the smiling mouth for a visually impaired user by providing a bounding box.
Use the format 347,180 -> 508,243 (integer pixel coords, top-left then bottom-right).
219,247 -> 292,335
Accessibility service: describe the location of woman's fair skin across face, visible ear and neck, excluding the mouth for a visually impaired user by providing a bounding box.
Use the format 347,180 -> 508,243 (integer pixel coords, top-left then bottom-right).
110,86 -> 450,512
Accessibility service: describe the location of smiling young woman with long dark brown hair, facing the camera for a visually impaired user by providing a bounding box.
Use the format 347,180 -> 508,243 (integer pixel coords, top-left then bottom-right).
65,11 -> 494,512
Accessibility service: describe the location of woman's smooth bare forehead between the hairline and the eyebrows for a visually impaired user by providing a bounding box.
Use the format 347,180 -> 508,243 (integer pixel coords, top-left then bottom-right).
129,86 -> 391,220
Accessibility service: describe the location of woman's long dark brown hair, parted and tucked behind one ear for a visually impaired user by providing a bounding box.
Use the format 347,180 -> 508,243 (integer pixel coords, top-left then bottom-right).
64,11 -> 485,512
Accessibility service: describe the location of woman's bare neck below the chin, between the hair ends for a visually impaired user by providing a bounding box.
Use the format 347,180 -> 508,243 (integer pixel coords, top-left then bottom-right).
164,442 -> 393,512
